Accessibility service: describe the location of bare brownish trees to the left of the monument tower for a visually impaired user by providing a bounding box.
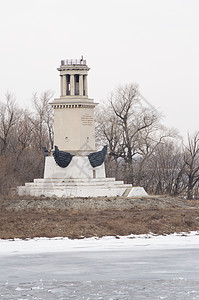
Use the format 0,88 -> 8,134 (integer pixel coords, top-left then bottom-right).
0,91 -> 53,194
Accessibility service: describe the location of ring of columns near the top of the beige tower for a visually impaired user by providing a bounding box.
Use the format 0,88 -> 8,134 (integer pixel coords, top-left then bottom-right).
60,74 -> 88,96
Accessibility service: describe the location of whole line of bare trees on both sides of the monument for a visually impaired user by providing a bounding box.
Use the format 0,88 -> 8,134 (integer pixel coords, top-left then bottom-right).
0,84 -> 199,199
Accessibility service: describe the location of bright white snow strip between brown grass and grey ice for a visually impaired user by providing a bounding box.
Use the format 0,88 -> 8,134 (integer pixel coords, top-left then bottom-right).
0,231 -> 199,255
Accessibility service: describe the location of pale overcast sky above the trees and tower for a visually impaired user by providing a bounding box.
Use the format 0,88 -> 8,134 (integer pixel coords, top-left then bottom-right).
0,0 -> 199,136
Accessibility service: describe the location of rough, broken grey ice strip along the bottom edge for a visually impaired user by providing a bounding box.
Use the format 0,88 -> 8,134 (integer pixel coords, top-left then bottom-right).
0,278 -> 199,300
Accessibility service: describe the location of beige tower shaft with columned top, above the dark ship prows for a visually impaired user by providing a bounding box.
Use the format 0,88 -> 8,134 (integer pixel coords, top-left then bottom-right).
51,58 -> 96,155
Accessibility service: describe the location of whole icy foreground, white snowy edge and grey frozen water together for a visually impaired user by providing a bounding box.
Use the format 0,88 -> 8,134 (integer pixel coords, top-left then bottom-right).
0,232 -> 199,300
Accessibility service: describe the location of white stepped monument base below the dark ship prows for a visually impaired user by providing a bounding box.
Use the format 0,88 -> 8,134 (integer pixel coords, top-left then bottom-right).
18,156 -> 147,198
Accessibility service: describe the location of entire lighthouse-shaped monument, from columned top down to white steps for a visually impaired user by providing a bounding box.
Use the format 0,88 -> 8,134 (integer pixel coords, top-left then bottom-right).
18,58 -> 147,197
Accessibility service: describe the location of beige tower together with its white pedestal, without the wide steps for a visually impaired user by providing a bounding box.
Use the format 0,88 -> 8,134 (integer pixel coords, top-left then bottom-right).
44,58 -> 106,179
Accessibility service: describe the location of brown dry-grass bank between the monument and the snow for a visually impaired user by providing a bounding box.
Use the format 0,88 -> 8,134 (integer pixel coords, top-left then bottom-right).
0,196 -> 199,239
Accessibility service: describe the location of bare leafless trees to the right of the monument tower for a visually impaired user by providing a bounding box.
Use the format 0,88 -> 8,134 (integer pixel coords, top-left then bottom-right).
96,84 -> 199,199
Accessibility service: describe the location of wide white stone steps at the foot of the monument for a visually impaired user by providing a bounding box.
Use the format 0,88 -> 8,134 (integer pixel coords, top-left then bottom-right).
18,178 -> 132,197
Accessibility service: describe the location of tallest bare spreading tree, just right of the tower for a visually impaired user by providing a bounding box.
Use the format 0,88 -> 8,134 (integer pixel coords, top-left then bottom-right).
97,84 -> 168,184
